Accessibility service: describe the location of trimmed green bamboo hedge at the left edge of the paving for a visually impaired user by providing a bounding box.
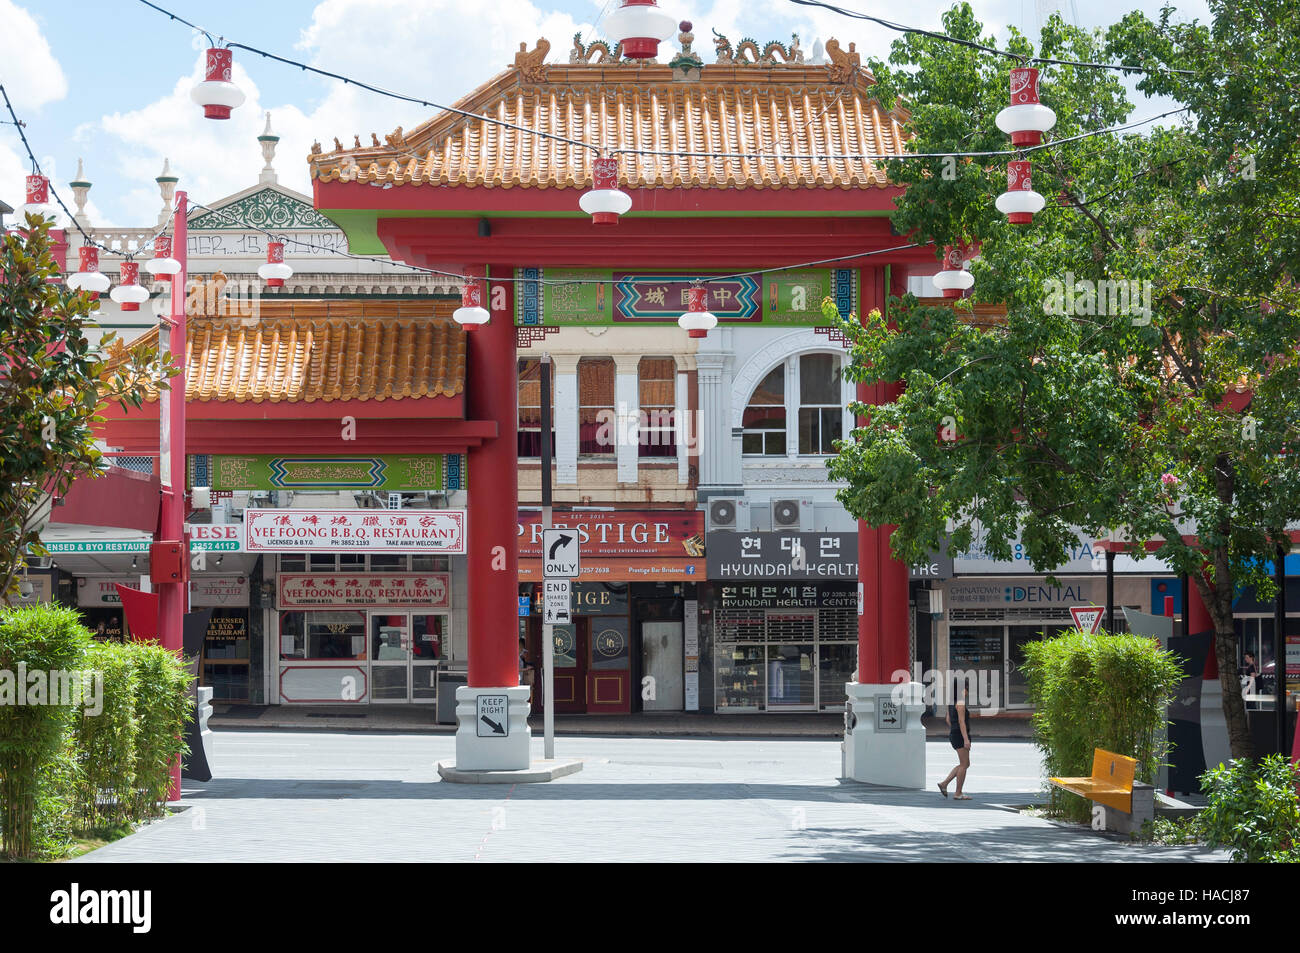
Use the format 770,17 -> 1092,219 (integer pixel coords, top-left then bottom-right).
0,606 -> 192,859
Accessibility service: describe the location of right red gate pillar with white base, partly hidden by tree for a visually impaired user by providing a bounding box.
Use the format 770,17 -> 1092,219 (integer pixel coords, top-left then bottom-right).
842,268 -> 926,788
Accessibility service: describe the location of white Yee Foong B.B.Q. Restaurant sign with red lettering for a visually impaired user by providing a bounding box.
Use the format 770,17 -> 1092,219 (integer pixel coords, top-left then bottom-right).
243,510 -> 465,555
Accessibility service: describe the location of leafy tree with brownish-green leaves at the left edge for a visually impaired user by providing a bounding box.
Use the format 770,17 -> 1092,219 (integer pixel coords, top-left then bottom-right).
0,216 -> 177,603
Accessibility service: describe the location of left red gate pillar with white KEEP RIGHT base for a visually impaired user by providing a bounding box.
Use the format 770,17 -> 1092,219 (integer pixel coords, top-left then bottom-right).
455,263 -> 529,771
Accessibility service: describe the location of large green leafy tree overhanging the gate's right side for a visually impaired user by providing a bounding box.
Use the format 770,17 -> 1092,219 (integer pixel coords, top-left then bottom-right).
827,0 -> 1300,757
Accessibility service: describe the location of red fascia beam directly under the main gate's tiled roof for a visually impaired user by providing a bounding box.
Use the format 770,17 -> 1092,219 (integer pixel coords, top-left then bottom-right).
312,181 -> 904,215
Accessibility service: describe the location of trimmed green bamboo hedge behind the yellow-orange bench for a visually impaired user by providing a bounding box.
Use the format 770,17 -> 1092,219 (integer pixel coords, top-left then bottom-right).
1022,629 -> 1183,822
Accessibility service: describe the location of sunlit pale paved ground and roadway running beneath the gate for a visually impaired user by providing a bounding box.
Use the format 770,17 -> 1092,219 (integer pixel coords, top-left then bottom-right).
77,731 -> 1226,863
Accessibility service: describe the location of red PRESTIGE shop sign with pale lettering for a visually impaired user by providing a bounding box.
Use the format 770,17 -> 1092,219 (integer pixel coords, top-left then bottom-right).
519,510 -> 705,582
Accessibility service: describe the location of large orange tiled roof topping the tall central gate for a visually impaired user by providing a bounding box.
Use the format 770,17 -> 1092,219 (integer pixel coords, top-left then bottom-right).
308,40 -> 906,189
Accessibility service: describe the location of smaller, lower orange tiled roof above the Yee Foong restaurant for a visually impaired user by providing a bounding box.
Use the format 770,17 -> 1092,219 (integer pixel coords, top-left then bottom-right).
126,302 -> 465,403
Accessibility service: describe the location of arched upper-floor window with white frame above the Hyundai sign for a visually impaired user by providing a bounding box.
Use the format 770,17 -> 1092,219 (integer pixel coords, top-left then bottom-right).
741,354 -> 844,456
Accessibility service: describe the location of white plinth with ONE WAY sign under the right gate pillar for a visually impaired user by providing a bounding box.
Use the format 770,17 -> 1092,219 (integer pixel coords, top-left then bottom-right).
842,681 -> 926,790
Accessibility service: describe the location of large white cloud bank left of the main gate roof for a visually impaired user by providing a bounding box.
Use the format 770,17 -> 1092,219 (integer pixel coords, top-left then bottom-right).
92,0 -> 595,225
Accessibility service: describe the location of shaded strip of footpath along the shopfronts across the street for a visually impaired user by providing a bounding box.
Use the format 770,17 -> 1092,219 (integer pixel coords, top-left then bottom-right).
208,705 -> 1032,741
